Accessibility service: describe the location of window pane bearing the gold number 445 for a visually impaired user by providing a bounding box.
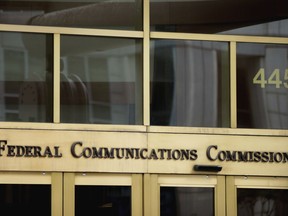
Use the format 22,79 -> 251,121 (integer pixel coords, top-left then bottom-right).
237,43 -> 288,129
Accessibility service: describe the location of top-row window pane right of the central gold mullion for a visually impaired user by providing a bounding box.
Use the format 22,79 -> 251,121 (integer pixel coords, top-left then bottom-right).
150,0 -> 288,36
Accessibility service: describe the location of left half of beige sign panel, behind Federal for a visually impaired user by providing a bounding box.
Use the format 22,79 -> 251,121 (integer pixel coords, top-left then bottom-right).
0,129 -> 147,173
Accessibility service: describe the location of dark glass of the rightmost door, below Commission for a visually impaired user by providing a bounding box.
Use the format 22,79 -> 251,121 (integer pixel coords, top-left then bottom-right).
237,189 -> 288,216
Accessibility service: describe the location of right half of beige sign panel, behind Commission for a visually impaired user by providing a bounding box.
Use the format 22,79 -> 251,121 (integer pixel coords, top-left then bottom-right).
148,133 -> 288,176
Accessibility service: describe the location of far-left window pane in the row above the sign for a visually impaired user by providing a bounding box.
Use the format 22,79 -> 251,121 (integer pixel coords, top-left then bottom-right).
0,32 -> 53,122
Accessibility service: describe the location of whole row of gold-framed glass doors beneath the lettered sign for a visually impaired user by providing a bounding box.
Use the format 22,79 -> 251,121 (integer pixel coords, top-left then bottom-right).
0,172 -> 288,216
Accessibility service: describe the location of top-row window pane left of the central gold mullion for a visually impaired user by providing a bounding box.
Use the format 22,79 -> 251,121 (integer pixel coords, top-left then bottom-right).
0,0 -> 142,30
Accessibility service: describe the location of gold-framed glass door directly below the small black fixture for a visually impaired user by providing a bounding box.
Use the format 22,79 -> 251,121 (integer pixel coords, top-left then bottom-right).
144,175 -> 225,216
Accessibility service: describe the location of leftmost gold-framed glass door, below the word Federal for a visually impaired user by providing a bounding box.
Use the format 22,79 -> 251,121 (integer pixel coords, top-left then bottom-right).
0,172 -> 62,216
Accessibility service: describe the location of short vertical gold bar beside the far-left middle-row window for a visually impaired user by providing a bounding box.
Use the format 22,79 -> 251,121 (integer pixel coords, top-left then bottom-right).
53,34 -> 60,123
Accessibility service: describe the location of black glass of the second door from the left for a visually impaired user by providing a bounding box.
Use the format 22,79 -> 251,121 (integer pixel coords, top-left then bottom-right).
75,186 -> 131,216
